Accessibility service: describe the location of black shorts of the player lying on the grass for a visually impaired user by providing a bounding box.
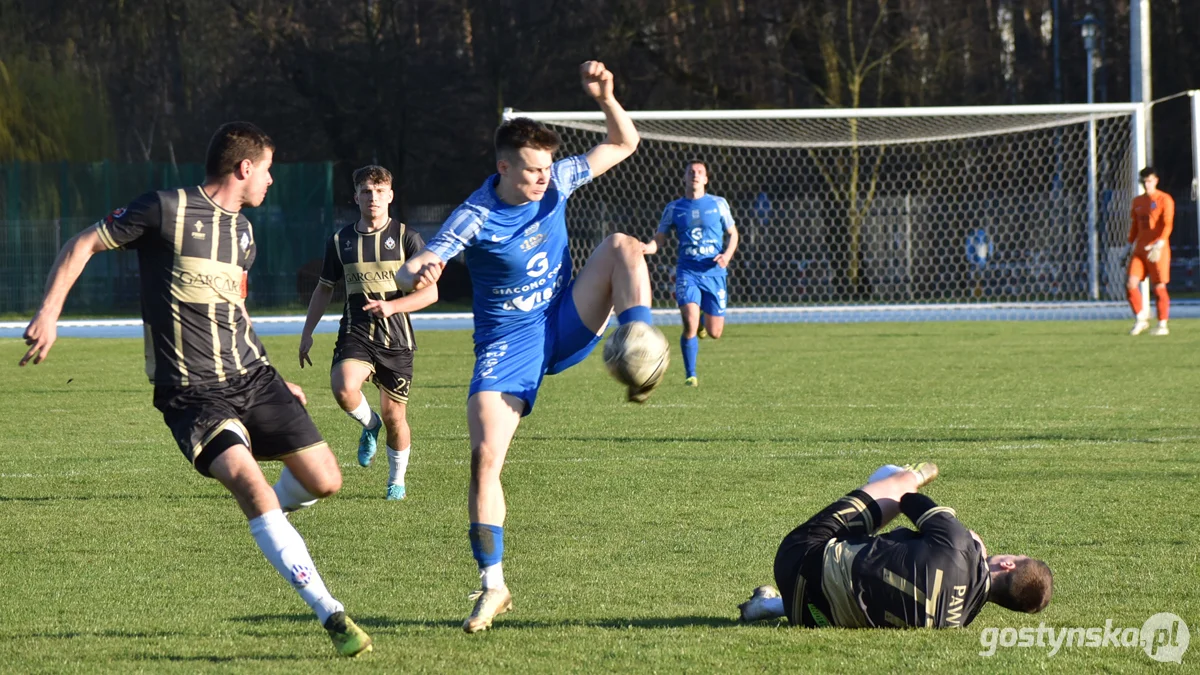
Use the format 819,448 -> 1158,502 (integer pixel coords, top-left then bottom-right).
775,490 -> 883,627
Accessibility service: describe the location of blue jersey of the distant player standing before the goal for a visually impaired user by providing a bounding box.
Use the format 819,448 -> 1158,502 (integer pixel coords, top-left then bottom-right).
658,195 -> 733,276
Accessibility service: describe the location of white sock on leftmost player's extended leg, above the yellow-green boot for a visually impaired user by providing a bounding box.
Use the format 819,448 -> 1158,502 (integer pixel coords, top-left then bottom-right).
250,510 -> 346,626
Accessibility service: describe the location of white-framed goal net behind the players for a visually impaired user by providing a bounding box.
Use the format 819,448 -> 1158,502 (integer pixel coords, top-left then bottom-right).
505,104 -> 1140,321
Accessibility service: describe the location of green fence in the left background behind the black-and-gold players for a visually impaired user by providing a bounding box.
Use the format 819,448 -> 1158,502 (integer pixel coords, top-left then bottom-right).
0,161 -> 338,316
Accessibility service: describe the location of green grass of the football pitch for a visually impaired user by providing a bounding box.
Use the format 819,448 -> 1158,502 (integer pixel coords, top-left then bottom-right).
0,321 -> 1200,674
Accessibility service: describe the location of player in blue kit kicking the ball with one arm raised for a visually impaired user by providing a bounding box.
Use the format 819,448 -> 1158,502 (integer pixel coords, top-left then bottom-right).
396,61 -> 650,633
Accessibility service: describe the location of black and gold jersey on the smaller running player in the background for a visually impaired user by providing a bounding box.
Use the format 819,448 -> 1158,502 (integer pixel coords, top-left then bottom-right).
319,219 -> 425,350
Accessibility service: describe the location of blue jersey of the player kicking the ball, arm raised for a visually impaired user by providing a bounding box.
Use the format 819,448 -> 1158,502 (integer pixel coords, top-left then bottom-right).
426,155 -> 592,345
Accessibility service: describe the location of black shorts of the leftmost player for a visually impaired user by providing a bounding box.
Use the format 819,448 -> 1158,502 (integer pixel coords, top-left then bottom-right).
154,365 -> 325,477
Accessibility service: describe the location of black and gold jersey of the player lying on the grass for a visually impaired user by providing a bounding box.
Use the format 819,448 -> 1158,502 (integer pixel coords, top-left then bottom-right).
821,492 -> 991,628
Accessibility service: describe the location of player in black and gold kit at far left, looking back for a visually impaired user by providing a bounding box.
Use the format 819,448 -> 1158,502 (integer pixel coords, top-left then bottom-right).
20,123 -> 371,656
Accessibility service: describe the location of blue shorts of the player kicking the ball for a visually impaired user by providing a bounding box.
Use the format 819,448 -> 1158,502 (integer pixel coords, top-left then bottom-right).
468,281 -> 604,416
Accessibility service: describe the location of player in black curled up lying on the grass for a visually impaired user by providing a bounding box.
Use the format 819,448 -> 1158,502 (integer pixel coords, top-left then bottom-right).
738,462 -> 1052,628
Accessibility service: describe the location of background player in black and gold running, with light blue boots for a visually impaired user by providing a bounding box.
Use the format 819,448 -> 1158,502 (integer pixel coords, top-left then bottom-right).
300,166 -> 438,500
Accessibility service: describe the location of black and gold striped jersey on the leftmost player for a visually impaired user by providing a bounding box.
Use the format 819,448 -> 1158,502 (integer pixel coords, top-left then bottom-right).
96,186 -> 269,387
